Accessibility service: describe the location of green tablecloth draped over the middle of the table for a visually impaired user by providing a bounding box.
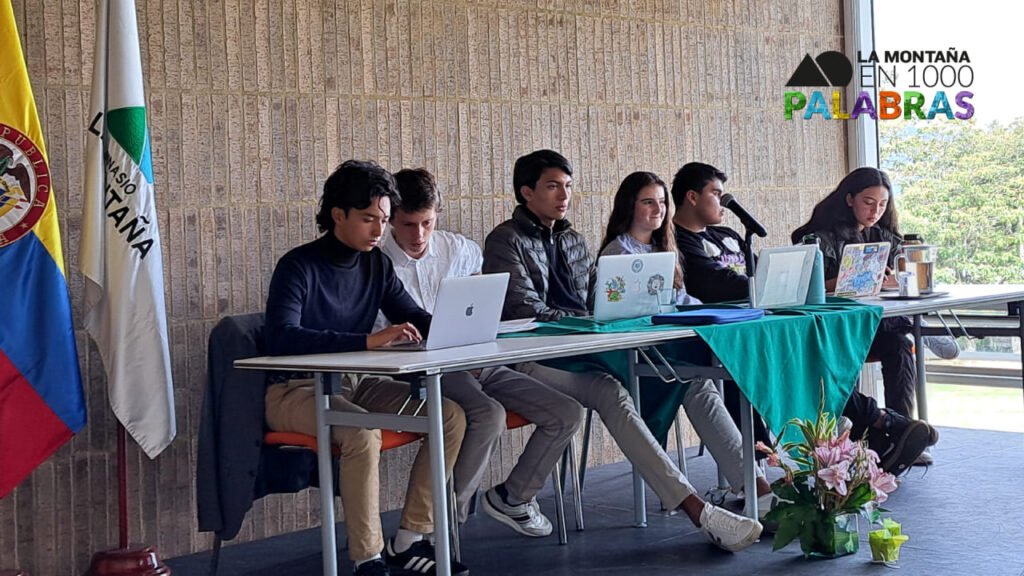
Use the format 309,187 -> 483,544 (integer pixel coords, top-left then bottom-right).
505,298 -> 882,443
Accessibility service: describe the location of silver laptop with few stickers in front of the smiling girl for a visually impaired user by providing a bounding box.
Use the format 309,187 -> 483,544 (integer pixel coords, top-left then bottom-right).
594,252 -> 678,321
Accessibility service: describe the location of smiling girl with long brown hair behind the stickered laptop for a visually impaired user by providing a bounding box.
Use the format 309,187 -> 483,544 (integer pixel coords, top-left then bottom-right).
600,172 -> 700,304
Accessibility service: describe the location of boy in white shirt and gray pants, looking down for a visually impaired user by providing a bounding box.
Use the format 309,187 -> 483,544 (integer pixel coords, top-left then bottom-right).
378,168 -> 583,537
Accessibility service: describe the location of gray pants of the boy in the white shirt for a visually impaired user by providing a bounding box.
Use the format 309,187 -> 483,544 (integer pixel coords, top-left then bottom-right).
441,366 -> 583,522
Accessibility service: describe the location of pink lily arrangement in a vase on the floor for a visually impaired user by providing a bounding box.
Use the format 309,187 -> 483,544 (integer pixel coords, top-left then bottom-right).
757,399 -> 897,558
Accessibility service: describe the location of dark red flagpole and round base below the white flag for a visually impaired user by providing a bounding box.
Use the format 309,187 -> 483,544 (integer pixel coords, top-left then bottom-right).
83,422 -> 171,576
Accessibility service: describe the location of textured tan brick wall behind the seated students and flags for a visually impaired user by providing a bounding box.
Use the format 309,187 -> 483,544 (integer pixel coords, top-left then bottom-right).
0,0 -> 846,575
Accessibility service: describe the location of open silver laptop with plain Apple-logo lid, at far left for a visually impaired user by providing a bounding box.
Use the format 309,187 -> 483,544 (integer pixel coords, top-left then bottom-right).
377,272 -> 509,352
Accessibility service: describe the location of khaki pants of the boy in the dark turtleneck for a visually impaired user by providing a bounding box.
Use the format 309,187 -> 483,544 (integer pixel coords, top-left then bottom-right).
266,377 -> 466,562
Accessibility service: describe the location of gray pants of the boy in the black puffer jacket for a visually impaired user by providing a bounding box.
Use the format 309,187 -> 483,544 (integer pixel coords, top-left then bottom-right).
516,362 -> 757,508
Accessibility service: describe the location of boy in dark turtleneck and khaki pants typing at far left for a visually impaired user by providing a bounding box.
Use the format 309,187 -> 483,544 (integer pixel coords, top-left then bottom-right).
265,160 -> 469,576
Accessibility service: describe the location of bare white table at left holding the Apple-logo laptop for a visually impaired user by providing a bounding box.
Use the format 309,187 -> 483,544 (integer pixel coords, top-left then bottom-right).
234,329 -> 700,576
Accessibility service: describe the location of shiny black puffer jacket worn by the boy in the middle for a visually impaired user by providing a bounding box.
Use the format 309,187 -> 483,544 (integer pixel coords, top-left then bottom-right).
483,206 -> 594,322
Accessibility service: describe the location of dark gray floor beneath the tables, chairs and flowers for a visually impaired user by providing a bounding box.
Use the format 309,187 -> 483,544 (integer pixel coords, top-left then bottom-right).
167,428 -> 1024,576
